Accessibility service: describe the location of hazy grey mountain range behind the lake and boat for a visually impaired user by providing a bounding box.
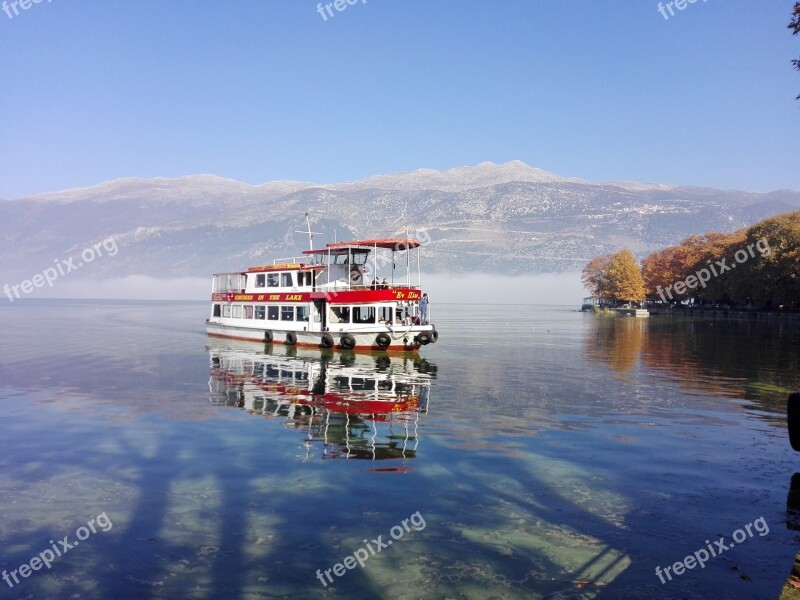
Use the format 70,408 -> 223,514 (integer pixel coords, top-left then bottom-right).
0,161 -> 800,284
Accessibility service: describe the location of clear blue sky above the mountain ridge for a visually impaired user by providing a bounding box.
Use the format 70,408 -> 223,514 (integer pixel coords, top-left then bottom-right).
0,0 -> 800,199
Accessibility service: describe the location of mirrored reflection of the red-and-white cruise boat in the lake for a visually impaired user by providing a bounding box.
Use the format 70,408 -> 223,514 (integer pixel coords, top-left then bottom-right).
203,340 -> 436,464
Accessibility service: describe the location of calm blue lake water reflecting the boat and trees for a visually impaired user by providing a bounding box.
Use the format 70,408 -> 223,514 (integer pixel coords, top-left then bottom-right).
0,300 -> 800,599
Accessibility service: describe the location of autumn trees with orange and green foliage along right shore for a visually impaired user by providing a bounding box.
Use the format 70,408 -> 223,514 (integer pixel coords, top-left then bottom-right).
582,211 -> 800,318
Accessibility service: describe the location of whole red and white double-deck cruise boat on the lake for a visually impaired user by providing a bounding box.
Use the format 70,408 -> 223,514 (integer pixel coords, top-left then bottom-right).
206,231 -> 439,352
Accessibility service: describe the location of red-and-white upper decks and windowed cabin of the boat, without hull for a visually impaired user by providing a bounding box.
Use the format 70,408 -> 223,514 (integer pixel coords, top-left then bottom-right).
206,238 -> 432,350
